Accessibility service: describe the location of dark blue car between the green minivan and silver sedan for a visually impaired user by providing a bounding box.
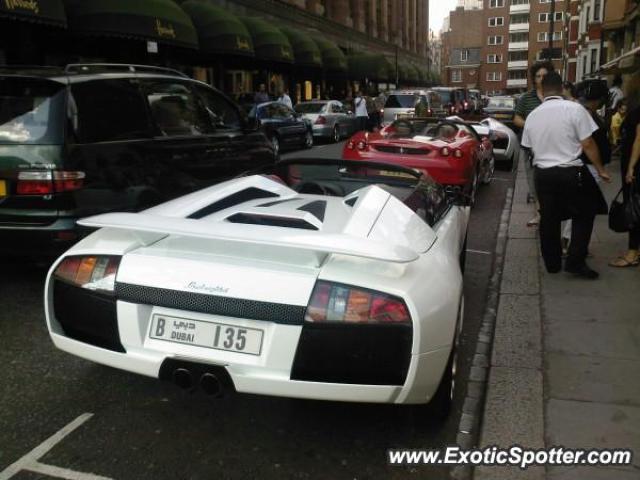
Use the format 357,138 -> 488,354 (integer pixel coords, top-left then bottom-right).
249,102 -> 313,152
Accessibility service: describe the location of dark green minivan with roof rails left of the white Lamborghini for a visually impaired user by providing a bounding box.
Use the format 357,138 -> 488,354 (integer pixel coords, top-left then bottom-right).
0,65 -> 277,254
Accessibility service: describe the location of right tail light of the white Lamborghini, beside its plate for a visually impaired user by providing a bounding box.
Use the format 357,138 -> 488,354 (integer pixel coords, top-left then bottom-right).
305,281 -> 411,324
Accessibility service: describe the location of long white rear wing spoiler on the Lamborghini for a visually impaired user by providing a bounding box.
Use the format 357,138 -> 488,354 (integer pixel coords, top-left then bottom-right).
78,213 -> 419,263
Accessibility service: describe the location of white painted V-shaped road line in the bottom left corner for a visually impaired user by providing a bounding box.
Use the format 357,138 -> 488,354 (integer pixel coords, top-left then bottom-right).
0,413 -> 111,480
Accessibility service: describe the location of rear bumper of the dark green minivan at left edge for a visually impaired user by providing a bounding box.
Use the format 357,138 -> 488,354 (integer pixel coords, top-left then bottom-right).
0,218 -> 79,255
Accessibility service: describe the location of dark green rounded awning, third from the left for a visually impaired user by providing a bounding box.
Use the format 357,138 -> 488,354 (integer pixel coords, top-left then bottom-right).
180,0 -> 254,57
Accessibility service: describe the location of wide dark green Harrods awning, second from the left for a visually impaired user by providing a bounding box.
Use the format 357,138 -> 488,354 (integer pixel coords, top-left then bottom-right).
65,0 -> 198,48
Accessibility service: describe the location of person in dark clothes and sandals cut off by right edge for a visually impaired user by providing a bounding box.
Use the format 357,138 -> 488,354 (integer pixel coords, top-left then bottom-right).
609,78 -> 640,267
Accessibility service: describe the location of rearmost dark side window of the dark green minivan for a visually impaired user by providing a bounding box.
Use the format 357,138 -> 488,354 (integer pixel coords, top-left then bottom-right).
69,79 -> 151,143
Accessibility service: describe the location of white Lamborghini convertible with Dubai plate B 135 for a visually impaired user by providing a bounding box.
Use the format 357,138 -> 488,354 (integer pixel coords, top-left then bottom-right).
45,159 -> 469,414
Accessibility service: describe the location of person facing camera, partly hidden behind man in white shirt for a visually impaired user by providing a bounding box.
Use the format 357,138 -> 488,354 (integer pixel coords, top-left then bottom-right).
513,61 -> 554,227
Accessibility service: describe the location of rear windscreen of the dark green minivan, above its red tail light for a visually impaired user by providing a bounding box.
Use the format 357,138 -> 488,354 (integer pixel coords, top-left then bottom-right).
0,77 -> 65,145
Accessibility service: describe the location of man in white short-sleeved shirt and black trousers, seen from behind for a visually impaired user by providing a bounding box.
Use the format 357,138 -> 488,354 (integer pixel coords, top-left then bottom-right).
521,72 -> 611,279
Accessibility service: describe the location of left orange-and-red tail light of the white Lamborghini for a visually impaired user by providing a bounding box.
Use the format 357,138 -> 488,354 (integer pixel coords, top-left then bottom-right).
53,255 -> 122,292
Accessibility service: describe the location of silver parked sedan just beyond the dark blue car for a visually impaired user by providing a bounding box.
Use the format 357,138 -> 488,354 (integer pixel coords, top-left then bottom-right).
295,100 -> 357,142
